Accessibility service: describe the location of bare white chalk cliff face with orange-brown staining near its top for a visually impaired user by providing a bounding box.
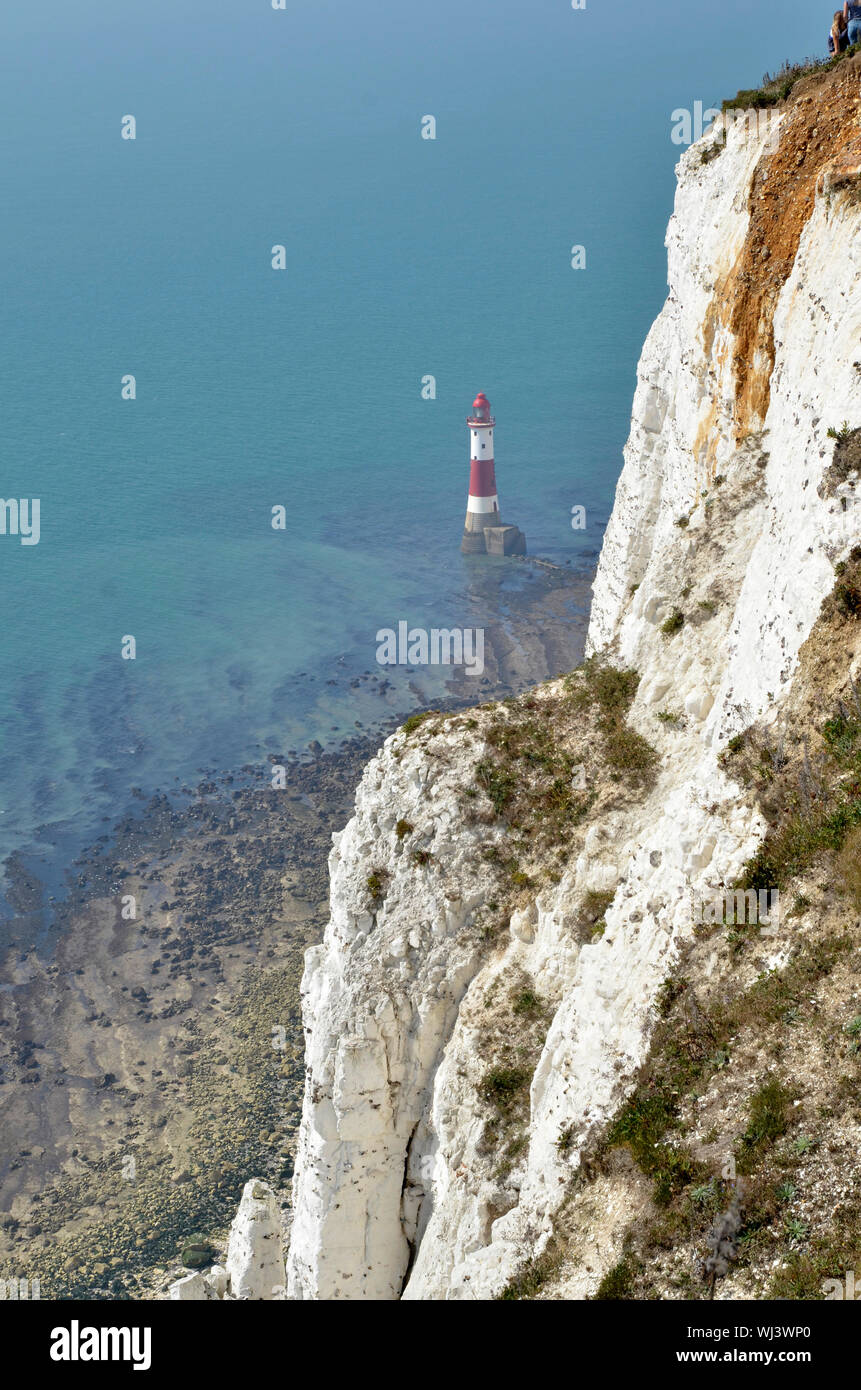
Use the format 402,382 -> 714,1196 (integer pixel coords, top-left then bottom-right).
288,64 -> 861,1298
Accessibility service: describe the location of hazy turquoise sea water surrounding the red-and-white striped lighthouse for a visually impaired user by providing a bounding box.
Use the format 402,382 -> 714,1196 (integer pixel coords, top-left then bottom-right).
0,0 -> 829,889
